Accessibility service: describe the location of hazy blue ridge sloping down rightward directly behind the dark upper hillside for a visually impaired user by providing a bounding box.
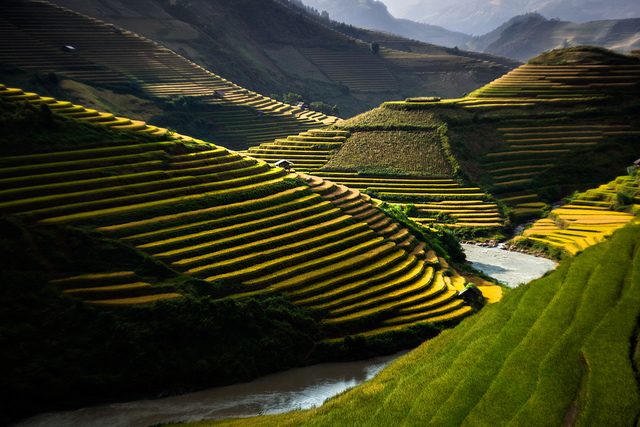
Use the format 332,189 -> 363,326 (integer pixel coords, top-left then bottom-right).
296,0 -> 471,47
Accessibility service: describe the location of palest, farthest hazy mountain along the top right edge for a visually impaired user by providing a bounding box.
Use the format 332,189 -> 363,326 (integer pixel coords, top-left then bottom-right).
384,0 -> 640,35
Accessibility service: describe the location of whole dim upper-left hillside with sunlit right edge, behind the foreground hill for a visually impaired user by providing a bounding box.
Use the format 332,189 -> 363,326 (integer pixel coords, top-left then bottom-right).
0,1 -> 344,148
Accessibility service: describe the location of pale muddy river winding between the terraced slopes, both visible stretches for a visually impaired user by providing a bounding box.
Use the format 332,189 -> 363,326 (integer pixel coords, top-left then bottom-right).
17,244 -> 556,427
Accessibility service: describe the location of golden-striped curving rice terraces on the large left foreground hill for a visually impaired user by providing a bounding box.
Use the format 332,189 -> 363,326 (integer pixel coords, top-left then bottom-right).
0,88 -> 490,332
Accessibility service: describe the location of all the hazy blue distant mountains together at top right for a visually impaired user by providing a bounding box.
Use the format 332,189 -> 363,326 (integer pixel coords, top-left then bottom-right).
302,0 -> 640,61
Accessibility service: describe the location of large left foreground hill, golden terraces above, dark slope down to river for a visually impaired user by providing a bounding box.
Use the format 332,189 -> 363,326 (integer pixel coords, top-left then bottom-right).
0,85 -> 510,422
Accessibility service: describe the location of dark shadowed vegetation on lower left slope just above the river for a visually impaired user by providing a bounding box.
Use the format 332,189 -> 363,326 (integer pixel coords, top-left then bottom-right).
0,219 -> 319,424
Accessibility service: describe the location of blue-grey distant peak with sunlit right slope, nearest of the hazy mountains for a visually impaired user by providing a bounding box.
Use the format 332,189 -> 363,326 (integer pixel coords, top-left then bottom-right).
464,13 -> 640,61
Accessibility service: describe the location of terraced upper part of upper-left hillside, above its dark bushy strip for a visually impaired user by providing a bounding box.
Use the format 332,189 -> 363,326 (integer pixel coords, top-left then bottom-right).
0,0 -> 337,150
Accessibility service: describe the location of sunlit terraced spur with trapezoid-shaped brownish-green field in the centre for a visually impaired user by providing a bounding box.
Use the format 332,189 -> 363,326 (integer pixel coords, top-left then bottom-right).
246,108 -> 504,236
